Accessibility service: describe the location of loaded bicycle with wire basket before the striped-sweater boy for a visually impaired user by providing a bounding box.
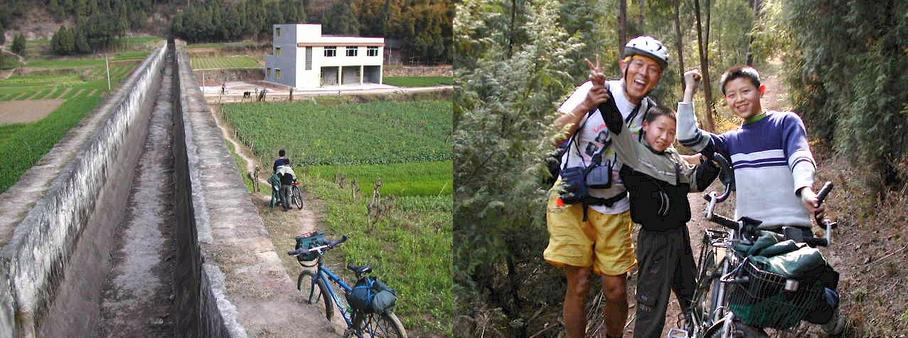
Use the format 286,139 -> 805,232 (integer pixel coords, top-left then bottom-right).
669,154 -> 838,337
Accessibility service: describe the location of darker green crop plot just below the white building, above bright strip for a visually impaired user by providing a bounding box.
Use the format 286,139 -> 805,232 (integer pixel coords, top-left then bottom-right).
222,101 -> 452,166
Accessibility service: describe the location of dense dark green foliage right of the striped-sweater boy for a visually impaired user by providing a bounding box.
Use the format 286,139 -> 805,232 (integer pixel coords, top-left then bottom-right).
763,0 -> 908,190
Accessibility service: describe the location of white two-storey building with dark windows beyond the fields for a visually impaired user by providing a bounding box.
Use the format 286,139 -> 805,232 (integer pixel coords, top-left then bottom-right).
265,24 -> 385,89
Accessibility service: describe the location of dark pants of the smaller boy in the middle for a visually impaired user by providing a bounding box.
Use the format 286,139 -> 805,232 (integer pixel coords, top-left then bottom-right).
634,226 -> 697,337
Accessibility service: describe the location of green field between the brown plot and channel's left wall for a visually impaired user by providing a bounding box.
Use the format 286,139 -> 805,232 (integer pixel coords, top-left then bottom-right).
0,96 -> 101,192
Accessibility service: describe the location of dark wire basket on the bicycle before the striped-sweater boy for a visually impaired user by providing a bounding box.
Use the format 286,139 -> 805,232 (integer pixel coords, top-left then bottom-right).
729,259 -> 823,329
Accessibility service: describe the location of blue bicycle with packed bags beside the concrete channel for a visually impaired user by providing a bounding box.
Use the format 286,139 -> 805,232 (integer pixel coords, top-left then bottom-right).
287,232 -> 407,338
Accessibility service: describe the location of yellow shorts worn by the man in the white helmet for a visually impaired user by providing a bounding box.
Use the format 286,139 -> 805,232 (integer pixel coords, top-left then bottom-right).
543,184 -> 637,276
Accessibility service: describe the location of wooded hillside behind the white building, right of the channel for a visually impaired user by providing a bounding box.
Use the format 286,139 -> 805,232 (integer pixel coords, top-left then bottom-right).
172,0 -> 454,63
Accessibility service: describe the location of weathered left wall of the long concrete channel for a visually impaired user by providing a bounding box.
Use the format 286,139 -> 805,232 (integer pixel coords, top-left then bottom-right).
0,44 -> 166,337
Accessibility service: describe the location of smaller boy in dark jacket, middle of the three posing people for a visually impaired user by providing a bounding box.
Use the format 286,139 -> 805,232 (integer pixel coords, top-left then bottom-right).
591,62 -> 718,337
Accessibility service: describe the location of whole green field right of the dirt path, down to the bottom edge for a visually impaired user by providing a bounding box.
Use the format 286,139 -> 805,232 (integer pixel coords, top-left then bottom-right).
220,100 -> 454,336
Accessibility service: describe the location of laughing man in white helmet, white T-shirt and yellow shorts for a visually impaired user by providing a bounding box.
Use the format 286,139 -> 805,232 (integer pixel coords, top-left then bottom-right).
543,36 -> 668,337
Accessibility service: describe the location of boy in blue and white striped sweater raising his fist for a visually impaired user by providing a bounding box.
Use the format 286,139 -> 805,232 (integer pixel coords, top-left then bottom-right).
678,66 -> 822,231
